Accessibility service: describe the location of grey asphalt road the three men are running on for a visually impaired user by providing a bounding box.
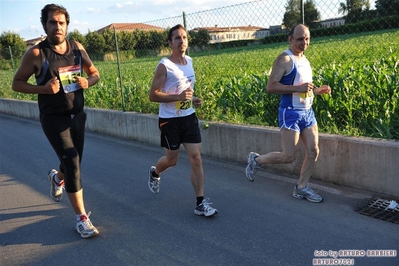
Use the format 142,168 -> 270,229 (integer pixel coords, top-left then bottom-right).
0,114 -> 399,266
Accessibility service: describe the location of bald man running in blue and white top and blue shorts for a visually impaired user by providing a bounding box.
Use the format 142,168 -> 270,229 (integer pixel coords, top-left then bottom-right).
245,24 -> 331,202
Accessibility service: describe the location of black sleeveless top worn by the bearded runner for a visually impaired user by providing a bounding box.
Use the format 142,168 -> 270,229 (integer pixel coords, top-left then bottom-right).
36,39 -> 84,114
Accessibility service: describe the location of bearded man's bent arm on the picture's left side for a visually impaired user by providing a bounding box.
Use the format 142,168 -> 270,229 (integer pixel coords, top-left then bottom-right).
12,46 -> 60,94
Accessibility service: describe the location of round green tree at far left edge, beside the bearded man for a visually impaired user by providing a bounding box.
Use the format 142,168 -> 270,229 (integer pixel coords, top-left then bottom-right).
0,31 -> 27,60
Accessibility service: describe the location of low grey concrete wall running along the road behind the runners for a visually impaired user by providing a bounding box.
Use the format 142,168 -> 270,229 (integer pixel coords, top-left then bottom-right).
0,98 -> 399,197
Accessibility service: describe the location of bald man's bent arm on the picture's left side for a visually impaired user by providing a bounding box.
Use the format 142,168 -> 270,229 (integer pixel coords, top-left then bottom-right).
266,53 -> 313,94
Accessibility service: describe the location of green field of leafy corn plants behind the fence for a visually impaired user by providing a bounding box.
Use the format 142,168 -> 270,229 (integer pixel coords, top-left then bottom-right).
0,30 -> 399,140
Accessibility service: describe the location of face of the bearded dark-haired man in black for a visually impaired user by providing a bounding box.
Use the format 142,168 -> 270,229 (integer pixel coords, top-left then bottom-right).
43,12 -> 68,44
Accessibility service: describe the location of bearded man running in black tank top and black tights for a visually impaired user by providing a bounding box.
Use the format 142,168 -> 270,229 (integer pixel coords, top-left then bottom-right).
12,4 -> 100,238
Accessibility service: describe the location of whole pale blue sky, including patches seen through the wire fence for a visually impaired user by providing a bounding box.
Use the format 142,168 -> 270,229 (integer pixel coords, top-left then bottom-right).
0,0 -> 374,40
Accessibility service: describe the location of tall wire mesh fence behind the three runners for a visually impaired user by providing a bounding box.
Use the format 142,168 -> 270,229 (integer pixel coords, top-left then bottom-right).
0,0 -> 399,139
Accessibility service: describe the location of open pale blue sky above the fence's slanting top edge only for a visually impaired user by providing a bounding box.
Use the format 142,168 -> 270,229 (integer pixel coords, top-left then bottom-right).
0,0 -> 249,40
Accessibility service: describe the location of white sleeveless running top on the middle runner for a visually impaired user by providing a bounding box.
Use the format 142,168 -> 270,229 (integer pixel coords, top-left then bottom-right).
157,55 -> 195,118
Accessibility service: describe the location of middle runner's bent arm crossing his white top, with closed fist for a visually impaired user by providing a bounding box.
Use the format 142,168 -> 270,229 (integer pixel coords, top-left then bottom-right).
149,64 -> 193,103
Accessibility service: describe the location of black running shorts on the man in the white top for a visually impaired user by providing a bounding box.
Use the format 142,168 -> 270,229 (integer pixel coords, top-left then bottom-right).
158,113 -> 201,150
